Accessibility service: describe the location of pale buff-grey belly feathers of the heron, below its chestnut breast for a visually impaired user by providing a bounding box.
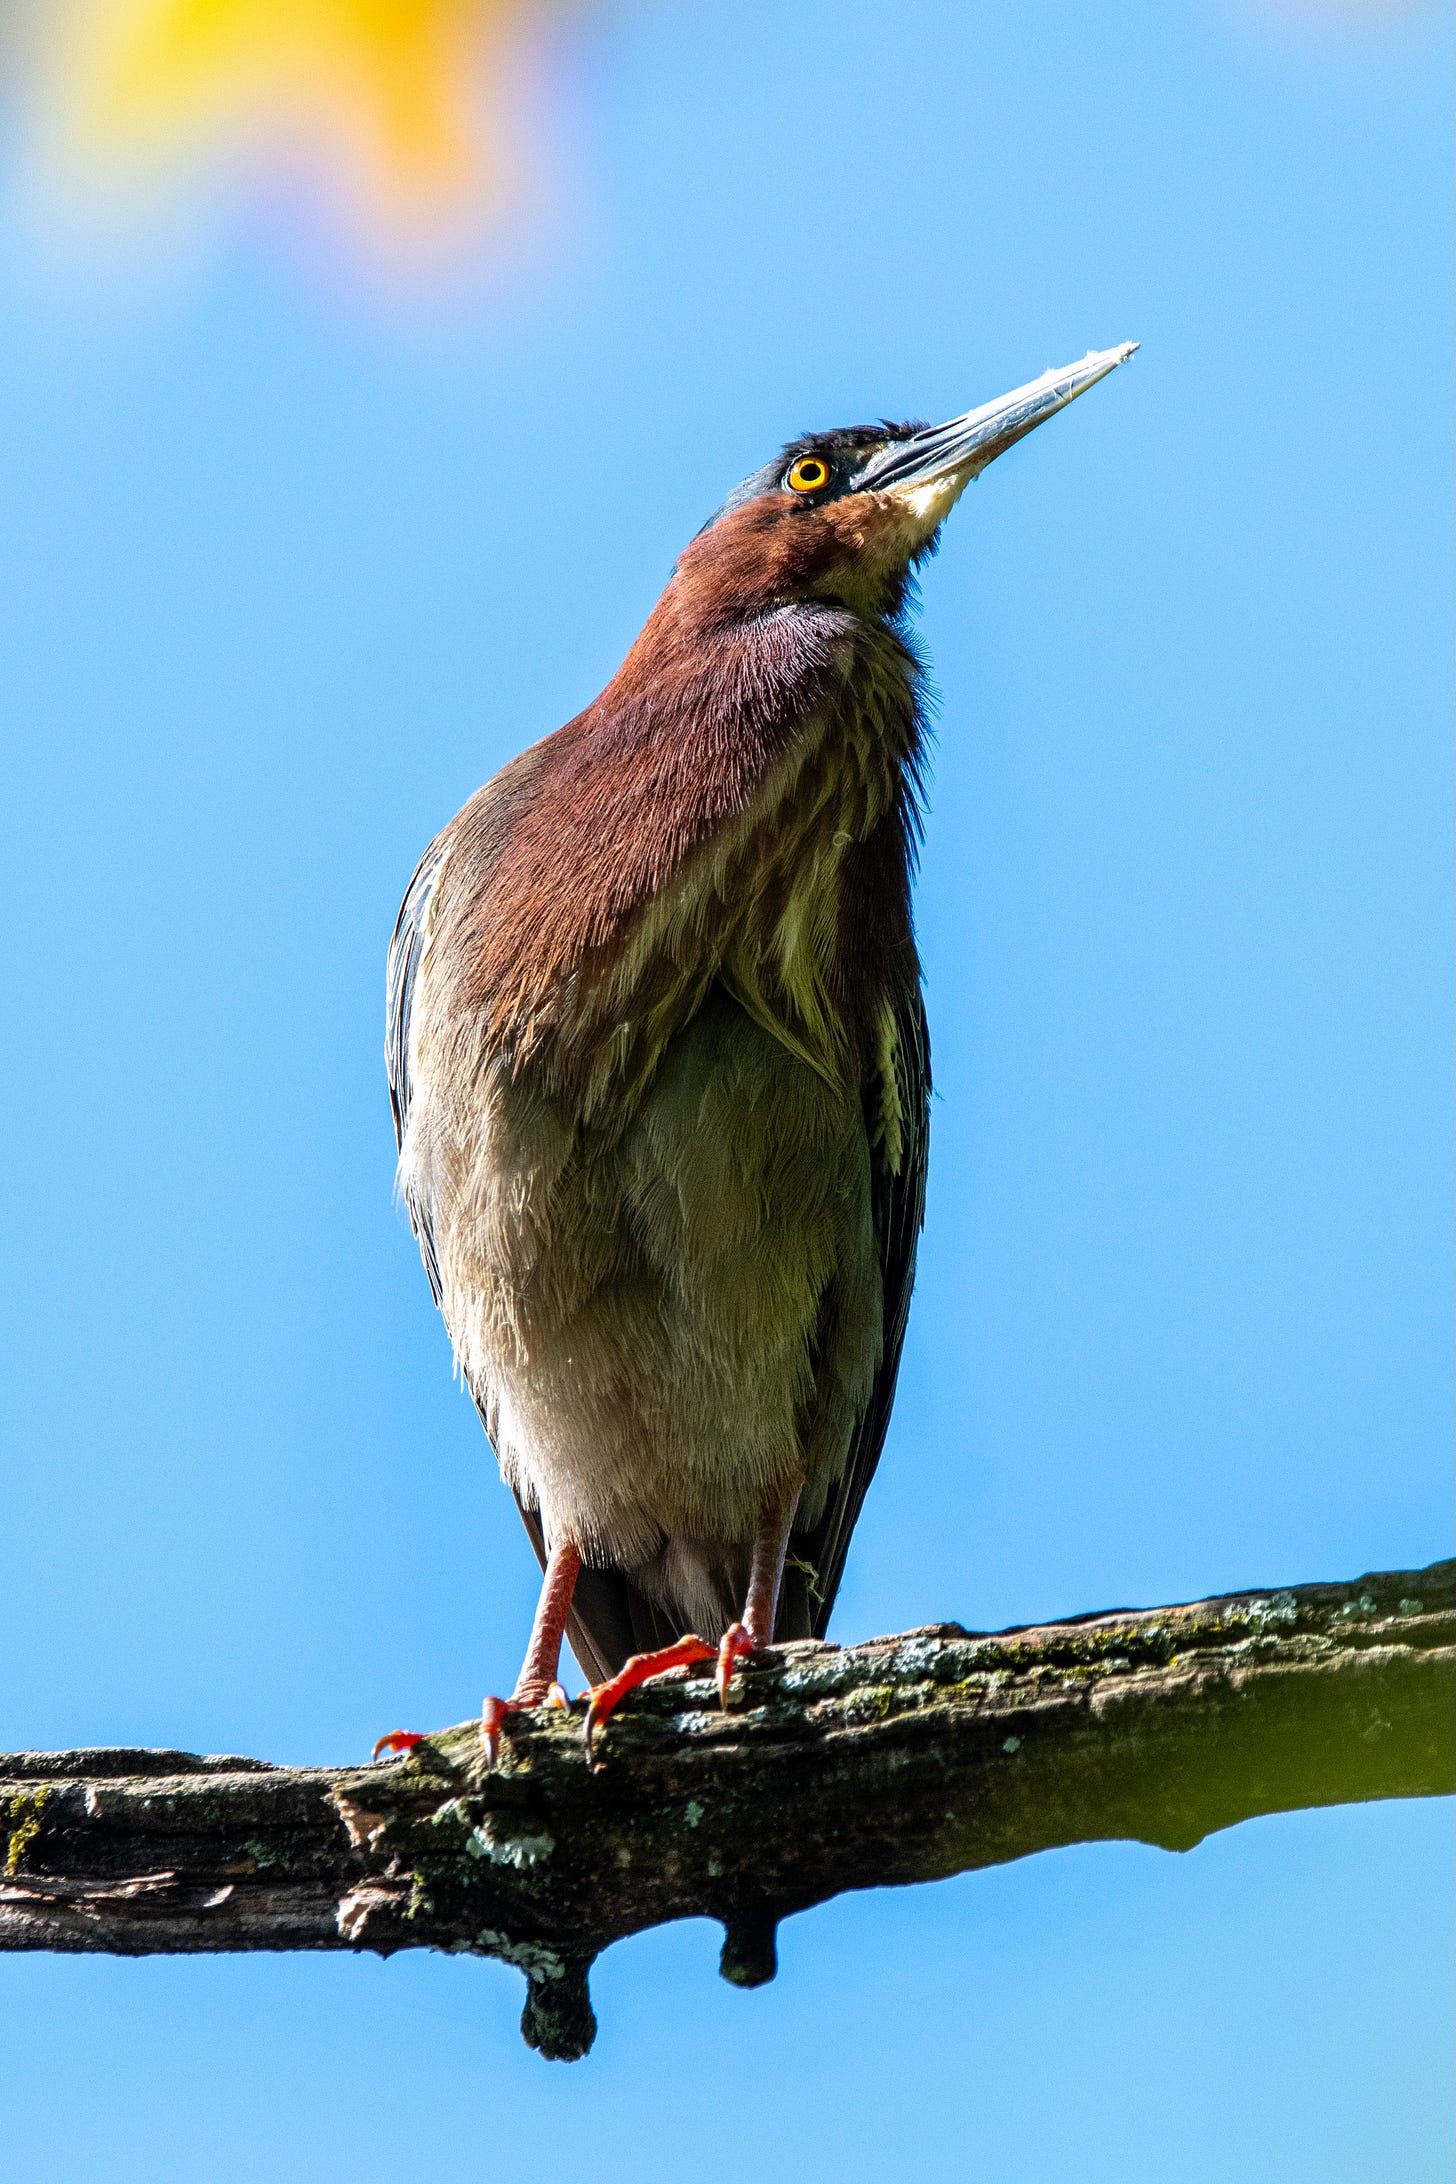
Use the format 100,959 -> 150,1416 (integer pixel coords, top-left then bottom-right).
399,987 -> 882,1627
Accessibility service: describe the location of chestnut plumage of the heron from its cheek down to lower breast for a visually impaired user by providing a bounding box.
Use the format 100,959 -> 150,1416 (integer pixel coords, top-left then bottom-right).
437,494 -> 921,1120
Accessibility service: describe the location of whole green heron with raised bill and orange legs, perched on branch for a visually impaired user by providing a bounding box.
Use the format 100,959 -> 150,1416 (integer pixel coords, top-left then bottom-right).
380,343 -> 1135,1760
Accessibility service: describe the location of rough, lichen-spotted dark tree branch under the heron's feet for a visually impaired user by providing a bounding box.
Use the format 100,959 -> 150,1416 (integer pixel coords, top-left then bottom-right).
0,1562 -> 1456,2057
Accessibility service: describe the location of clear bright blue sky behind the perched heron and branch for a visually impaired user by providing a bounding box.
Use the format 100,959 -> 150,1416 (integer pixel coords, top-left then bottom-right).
0,0 -> 1452,2184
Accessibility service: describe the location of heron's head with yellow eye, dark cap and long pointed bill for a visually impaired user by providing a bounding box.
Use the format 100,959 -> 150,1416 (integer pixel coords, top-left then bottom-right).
677,341 -> 1137,618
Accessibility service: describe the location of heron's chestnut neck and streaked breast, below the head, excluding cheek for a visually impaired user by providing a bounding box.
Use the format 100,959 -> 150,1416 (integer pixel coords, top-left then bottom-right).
467,594 -> 919,1105
